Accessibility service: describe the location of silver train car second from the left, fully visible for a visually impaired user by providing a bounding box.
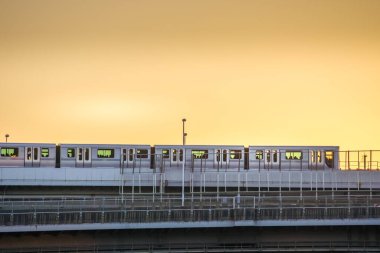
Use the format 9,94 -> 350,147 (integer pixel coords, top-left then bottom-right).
59,144 -> 151,172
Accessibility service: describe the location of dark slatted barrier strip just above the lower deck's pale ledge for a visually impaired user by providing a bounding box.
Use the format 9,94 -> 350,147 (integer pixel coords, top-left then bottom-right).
0,206 -> 380,226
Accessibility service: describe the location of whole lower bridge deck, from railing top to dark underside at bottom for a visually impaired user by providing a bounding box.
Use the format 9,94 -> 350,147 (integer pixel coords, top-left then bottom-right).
0,189 -> 380,252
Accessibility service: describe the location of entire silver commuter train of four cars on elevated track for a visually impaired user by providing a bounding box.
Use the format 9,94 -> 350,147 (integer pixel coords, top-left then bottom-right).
0,143 -> 339,173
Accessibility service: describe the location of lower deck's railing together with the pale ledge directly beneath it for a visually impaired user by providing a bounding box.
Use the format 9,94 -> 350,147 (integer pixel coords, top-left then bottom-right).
0,194 -> 380,232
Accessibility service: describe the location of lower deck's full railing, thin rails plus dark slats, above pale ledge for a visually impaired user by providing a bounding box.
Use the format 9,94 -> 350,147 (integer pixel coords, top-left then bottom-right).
0,195 -> 380,226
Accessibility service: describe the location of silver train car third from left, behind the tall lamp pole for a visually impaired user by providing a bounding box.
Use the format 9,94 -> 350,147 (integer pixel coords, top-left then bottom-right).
155,145 -> 245,172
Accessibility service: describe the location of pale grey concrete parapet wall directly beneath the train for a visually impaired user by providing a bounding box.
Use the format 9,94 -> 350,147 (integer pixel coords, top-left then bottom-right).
0,167 -> 380,192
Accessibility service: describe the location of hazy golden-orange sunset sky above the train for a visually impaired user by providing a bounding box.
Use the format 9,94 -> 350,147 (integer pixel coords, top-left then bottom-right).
0,0 -> 380,149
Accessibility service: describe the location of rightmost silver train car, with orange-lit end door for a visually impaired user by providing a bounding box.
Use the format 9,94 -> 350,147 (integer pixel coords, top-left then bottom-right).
248,146 -> 339,170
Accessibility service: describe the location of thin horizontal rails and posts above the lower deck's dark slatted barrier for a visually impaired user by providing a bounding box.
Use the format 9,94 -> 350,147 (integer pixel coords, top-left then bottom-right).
0,191 -> 380,213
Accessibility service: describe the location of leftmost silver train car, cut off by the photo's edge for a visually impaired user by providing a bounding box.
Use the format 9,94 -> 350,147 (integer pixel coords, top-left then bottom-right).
0,143 -> 56,168
